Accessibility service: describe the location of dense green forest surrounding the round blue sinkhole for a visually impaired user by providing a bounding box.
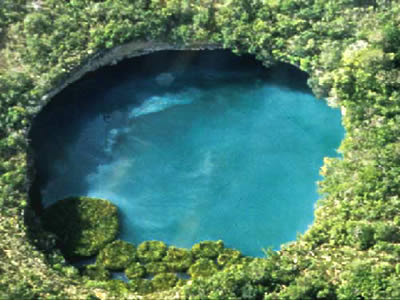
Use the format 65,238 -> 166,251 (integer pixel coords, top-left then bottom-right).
0,0 -> 400,299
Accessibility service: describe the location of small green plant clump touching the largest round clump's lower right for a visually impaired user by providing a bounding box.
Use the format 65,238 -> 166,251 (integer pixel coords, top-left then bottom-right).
96,240 -> 137,271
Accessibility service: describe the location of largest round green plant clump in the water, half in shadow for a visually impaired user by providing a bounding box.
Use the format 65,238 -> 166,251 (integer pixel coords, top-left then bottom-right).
42,197 -> 119,257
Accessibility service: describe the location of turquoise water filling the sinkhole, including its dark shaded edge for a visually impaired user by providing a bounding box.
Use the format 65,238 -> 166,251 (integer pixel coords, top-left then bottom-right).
30,50 -> 344,256
